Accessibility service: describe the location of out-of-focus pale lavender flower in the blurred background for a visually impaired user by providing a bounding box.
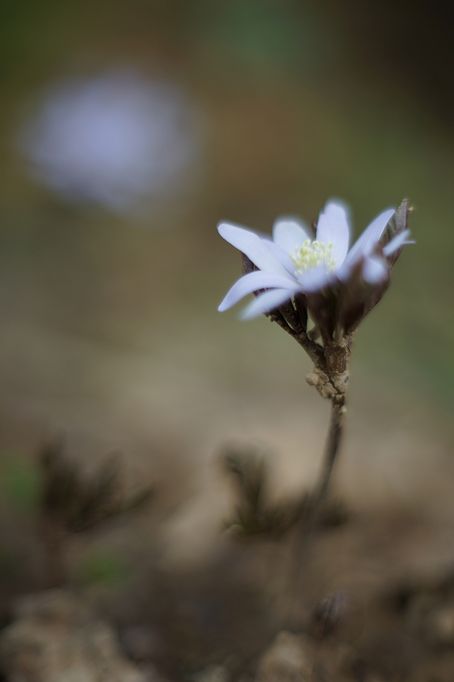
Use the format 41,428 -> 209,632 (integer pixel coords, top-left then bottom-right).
21,72 -> 197,210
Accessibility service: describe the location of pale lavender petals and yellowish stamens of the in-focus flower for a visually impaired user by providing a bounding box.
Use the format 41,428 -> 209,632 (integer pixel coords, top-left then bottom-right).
218,200 -> 410,319
